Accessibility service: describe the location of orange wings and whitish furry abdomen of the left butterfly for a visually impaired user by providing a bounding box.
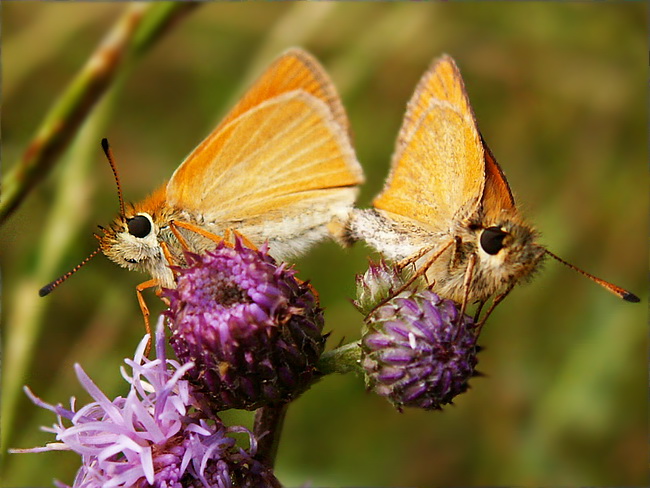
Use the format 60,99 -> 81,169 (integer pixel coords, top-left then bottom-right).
166,50 -> 363,254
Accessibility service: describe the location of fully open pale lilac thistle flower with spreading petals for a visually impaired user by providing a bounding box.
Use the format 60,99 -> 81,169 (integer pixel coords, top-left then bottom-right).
12,320 -> 280,488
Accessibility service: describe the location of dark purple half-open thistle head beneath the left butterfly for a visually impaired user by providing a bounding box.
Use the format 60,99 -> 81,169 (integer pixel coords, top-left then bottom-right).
164,239 -> 325,411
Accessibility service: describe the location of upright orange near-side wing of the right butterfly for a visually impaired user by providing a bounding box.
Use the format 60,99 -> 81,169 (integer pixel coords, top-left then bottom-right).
373,56 -> 485,231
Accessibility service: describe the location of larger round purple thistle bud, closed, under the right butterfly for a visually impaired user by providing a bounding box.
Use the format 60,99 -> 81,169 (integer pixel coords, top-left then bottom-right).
361,290 -> 477,410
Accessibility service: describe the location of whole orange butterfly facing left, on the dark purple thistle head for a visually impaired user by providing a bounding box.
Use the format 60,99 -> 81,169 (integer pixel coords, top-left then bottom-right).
41,49 -> 364,320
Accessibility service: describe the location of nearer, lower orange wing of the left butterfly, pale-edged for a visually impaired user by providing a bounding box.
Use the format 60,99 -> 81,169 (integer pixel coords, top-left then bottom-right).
167,92 -> 363,220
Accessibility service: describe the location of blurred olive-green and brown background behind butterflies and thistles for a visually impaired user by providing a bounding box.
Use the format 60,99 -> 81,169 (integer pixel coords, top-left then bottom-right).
0,2 -> 648,487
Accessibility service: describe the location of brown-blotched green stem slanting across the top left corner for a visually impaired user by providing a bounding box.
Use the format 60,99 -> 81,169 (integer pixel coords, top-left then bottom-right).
0,2 -> 198,225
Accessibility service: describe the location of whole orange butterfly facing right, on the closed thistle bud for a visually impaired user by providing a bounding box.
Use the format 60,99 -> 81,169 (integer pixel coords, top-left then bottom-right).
348,56 -> 639,321
